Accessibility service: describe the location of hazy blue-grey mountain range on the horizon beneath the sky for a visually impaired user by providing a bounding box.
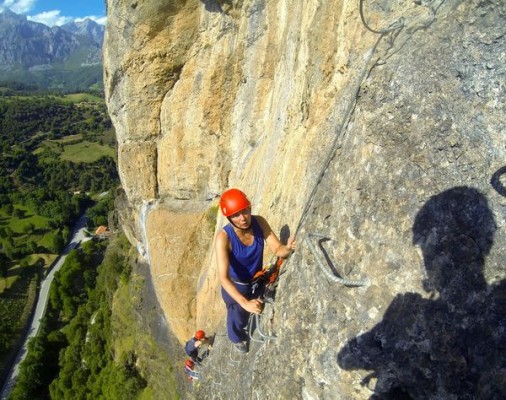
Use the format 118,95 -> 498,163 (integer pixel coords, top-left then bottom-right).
0,10 -> 105,91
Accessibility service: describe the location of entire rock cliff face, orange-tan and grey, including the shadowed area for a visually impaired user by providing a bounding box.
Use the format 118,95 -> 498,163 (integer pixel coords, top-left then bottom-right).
104,0 -> 506,399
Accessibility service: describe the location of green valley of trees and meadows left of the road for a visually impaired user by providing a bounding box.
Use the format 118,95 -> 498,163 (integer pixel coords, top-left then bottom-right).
0,85 -> 118,390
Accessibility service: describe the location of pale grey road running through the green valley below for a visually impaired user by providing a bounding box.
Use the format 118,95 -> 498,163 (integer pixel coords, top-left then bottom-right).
0,215 -> 91,400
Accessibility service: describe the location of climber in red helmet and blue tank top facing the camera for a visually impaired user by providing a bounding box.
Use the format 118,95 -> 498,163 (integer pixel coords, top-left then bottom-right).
215,189 -> 296,353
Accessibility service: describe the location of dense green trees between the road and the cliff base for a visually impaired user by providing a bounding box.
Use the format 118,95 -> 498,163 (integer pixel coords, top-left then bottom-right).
11,238 -> 152,400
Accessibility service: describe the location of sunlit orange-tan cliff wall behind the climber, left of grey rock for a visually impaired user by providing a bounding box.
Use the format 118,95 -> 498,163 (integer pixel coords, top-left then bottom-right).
104,1 -> 384,339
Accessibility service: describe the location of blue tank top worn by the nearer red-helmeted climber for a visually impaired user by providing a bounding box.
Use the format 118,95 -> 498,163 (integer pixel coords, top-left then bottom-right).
223,217 -> 264,282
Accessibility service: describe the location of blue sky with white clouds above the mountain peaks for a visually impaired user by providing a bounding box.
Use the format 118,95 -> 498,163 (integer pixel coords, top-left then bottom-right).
0,0 -> 106,26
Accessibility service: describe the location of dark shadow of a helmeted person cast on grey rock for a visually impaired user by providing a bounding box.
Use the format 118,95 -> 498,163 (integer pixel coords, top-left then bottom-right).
337,187 -> 506,400
